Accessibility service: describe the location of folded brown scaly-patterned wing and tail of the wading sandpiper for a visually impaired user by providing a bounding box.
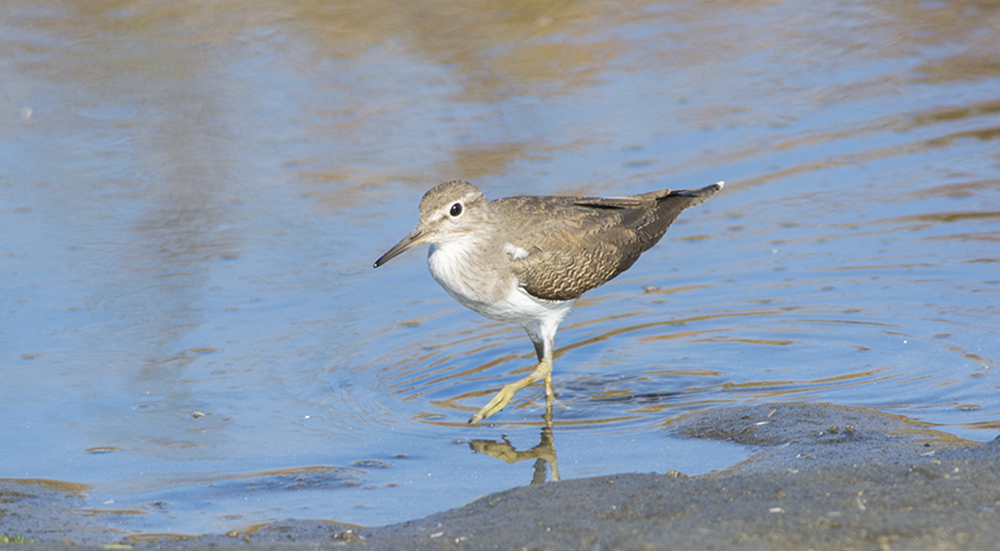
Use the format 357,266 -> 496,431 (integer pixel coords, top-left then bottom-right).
494,185 -> 721,300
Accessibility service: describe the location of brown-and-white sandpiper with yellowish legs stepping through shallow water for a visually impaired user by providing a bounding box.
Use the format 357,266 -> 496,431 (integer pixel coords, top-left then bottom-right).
375,180 -> 723,423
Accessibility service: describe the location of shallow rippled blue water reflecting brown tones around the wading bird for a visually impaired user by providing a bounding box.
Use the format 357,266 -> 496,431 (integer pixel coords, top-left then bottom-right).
0,0 -> 1000,544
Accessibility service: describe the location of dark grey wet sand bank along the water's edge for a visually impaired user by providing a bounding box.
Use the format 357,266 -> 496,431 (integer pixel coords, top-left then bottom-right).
7,404 -> 1000,551
